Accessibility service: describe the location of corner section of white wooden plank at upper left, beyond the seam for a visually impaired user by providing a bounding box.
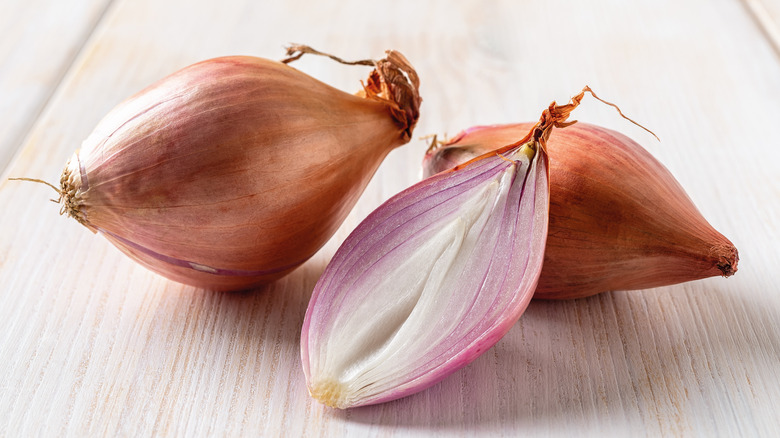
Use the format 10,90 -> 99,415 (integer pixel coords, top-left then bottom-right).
0,0 -> 111,173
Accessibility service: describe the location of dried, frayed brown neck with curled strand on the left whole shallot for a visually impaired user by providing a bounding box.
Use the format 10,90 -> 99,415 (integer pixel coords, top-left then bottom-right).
281,44 -> 422,142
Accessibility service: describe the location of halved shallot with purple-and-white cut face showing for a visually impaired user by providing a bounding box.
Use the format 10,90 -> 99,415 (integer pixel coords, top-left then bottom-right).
301,145 -> 549,408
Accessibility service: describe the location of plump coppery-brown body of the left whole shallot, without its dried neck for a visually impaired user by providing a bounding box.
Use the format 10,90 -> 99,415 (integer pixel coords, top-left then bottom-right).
62,52 -> 420,290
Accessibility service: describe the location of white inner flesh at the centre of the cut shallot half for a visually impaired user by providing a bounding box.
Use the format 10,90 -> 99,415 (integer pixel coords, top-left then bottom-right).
310,161 -> 528,408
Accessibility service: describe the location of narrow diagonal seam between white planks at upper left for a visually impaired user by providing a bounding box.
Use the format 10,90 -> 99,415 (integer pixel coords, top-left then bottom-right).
0,0 -> 118,181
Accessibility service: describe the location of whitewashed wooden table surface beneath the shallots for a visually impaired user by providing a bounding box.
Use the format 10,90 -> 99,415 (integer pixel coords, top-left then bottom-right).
0,0 -> 780,437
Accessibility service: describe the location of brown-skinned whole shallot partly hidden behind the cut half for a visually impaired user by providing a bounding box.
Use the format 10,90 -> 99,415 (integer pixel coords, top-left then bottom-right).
423,123 -> 739,299
